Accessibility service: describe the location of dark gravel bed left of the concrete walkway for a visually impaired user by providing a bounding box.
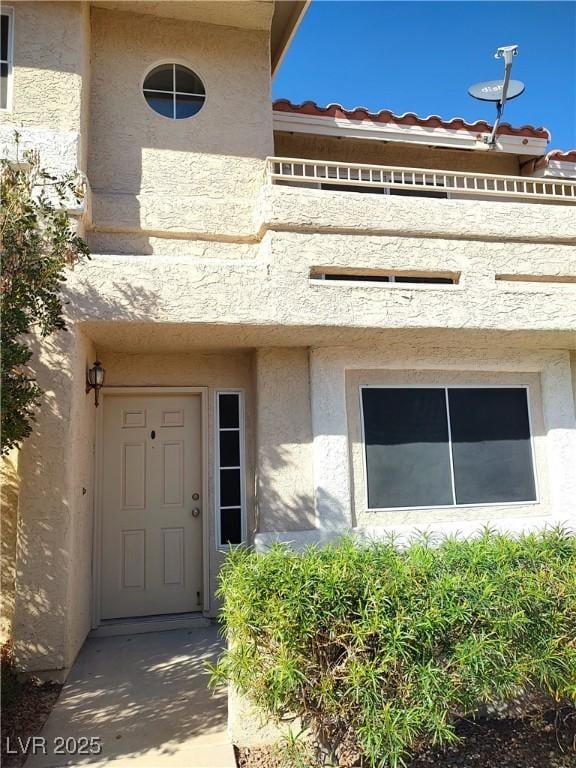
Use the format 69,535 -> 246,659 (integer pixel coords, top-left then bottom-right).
0,674 -> 62,768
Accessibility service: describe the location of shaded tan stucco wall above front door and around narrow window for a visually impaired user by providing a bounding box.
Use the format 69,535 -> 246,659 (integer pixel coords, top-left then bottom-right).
101,352 -> 255,615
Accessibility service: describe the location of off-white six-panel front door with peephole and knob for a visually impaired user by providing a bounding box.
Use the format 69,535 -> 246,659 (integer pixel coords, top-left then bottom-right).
101,394 -> 204,619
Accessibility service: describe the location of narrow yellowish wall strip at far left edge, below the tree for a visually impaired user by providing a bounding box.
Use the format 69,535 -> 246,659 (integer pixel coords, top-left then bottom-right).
0,449 -> 20,644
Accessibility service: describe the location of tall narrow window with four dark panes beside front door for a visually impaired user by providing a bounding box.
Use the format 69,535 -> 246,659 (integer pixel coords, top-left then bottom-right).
216,392 -> 245,547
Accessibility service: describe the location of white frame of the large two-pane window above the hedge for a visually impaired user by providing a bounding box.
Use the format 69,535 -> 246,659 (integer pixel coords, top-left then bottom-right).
359,382 -> 540,513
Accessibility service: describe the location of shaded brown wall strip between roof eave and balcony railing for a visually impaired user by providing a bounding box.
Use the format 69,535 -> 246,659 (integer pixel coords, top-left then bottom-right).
274,132 -> 520,176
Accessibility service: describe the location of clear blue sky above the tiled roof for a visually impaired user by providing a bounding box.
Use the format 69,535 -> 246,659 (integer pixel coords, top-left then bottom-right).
273,0 -> 576,149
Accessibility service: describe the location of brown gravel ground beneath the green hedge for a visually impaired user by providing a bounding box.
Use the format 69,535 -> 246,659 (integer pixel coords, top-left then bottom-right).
237,712 -> 576,768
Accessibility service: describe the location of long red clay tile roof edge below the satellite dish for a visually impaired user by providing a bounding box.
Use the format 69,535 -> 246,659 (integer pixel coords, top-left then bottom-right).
272,99 -> 550,141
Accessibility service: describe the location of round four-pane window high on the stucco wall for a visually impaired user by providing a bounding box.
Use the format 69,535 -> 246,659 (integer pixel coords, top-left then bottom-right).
142,64 -> 206,120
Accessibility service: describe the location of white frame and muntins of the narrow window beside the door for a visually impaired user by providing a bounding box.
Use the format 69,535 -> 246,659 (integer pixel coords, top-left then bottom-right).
214,389 -> 248,552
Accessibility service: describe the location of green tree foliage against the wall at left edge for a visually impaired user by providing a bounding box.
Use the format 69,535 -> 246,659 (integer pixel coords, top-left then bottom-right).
0,137 -> 88,454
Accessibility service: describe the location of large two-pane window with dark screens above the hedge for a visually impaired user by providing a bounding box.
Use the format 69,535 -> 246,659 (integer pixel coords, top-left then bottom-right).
361,387 -> 536,509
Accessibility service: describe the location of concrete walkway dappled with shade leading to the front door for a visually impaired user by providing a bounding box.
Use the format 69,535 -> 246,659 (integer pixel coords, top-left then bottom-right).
25,626 -> 236,768
